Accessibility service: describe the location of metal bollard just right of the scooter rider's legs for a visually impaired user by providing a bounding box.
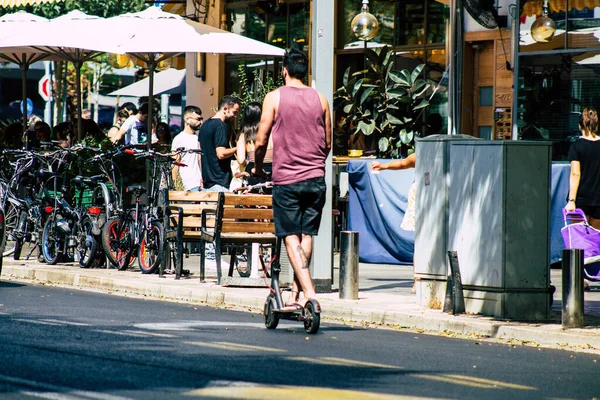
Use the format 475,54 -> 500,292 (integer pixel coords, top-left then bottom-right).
340,231 -> 358,300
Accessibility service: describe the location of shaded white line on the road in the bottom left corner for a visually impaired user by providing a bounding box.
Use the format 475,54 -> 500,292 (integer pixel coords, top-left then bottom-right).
0,375 -> 132,400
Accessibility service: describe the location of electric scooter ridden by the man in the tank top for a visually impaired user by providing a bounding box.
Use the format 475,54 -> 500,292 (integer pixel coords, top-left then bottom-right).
264,238 -> 321,334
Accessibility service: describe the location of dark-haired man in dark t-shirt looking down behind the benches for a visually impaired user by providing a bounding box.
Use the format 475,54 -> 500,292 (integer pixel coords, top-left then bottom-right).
198,96 -> 240,192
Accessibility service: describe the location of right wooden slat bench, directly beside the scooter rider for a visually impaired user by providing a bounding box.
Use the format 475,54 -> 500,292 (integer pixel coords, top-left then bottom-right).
200,193 -> 276,284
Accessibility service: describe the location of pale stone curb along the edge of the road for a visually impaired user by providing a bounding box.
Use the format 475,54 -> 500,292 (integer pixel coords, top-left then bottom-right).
2,264 -> 600,354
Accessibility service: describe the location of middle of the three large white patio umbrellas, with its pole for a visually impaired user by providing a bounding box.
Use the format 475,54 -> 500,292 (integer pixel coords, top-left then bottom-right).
0,10 -> 127,138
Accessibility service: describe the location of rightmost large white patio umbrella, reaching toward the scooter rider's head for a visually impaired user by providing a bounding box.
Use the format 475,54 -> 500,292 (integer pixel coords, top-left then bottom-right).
106,7 -> 284,147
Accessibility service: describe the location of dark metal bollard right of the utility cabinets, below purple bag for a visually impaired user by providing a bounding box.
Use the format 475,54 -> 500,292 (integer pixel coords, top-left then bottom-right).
562,249 -> 583,328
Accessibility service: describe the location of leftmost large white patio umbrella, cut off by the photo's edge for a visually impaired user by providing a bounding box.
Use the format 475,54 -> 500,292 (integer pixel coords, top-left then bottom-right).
0,11 -> 48,131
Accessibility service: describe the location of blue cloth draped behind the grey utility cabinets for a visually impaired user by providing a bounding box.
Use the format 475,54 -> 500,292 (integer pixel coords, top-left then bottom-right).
347,159 -> 570,264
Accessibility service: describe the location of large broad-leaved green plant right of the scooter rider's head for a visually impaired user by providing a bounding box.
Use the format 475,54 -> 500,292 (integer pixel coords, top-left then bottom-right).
334,46 -> 431,158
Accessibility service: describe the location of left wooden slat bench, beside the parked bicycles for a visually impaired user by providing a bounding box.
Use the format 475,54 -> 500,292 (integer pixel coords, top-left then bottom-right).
159,190 -> 219,280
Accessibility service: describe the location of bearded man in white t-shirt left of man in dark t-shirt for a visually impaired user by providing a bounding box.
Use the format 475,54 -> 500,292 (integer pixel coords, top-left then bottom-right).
171,106 -> 203,192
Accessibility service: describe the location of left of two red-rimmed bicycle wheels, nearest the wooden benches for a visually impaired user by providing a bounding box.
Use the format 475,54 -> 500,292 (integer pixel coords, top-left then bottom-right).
101,217 -> 134,271
